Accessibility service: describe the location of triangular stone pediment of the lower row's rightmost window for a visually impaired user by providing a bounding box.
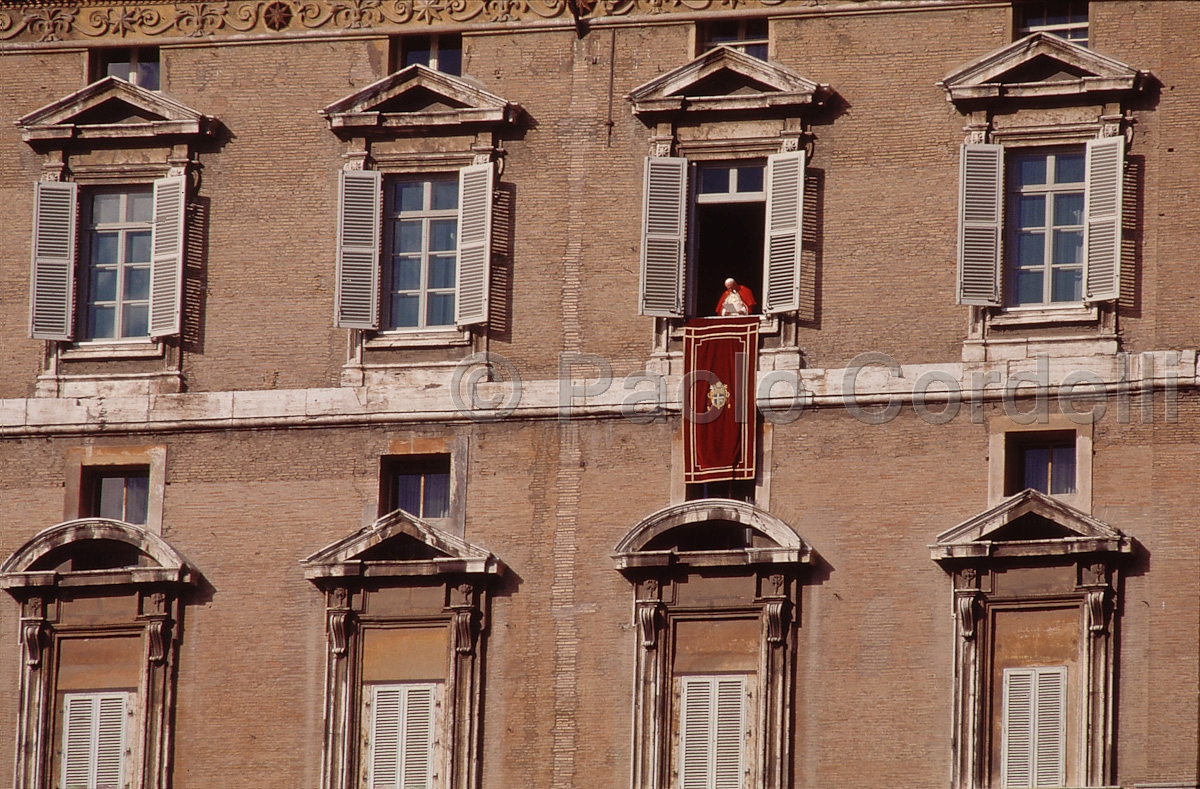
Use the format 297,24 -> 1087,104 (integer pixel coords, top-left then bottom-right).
930,489 -> 1132,560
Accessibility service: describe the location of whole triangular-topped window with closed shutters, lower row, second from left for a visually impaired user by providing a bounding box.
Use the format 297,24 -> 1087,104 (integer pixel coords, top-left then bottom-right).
304,510 -> 504,789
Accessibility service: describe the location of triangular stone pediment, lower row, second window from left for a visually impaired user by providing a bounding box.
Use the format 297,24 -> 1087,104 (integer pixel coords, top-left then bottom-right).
301,510 -> 504,580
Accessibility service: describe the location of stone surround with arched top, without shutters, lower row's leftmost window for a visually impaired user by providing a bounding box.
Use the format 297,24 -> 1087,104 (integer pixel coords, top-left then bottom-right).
0,518 -> 200,789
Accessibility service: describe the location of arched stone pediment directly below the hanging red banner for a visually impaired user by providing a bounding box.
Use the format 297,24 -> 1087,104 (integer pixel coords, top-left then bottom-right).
613,499 -> 812,570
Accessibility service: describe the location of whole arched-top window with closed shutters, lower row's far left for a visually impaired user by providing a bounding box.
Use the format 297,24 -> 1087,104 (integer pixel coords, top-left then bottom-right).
0,518 -> 198,789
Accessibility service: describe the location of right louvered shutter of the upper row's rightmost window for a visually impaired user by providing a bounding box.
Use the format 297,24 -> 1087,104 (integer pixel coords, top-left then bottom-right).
1084,137 -> 1124,301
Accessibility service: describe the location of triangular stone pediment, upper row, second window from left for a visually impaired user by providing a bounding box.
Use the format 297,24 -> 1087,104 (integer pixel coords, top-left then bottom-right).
320,64 -> 521,130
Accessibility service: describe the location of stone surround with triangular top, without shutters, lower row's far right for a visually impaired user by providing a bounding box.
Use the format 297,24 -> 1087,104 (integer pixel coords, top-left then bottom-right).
930,489 -> 1134,789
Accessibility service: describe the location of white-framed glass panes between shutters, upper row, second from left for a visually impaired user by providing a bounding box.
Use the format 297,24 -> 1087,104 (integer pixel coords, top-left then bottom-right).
384,177 -> 458,329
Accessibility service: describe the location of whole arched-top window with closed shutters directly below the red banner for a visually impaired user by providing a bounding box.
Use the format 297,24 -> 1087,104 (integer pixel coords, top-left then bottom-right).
613,501 -> 812,789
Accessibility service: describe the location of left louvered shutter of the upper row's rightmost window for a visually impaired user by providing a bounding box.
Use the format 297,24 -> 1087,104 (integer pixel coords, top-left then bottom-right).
959,144 -> 1004,306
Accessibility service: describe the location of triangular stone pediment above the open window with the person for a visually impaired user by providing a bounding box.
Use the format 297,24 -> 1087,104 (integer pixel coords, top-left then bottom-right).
626,47 -> 828,115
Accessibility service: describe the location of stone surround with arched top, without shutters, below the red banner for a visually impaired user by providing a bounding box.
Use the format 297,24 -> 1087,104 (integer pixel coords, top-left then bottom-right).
613,500 -> 815,789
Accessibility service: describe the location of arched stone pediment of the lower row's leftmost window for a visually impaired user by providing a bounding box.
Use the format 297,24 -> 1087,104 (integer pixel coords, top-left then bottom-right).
0,518 -> 198,589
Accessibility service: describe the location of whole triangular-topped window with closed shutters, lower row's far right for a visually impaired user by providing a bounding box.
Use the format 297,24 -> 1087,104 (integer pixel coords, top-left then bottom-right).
930,489 -> 1133,789
